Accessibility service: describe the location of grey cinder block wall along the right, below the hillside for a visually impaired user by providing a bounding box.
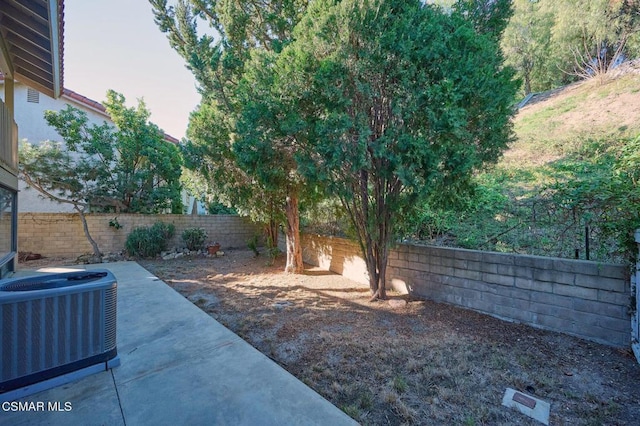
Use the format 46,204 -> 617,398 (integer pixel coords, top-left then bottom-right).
303,235 -> 631,347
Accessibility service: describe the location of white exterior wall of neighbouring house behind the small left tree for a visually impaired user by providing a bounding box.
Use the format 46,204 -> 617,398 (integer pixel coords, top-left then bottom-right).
0,81 -> 111,213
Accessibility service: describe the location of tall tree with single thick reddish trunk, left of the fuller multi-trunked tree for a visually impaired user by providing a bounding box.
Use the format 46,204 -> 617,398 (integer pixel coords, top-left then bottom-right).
150,0 -> 308,273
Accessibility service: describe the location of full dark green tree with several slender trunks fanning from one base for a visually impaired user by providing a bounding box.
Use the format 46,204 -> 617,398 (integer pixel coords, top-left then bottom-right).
273,0 -> 516,299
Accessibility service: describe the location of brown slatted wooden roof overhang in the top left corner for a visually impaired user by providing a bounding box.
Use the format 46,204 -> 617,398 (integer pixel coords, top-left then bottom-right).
0,0 -> 64,98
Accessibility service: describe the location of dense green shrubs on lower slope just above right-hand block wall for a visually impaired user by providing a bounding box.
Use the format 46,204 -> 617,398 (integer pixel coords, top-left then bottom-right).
416,138 -> 640,263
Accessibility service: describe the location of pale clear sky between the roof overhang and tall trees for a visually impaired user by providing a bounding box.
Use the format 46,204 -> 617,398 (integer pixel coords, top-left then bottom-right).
64,0 -> 200,139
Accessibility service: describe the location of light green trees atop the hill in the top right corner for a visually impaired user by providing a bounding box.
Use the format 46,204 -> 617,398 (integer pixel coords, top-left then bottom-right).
502,0 -> 640,94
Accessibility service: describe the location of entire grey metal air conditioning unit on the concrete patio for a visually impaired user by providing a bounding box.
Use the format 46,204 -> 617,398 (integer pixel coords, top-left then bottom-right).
0,269 -> 119,400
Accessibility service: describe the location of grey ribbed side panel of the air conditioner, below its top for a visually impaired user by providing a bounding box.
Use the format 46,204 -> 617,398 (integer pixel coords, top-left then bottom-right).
0,273 -> 117,393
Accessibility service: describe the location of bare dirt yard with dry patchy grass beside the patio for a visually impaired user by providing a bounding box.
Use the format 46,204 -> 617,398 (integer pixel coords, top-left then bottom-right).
22,250 -> 640,425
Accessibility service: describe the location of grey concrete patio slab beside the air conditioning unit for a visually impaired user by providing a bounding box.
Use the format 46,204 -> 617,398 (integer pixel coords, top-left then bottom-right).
0,262 -> 356,426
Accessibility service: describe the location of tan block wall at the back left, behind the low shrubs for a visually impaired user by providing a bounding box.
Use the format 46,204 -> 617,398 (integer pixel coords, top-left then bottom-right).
18,213 -> 261,256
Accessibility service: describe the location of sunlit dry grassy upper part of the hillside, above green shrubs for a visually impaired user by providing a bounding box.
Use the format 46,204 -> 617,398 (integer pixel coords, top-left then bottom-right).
502,62 -> 640,166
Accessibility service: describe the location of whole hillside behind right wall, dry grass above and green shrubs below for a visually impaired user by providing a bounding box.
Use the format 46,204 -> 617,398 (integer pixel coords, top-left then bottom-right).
410,66 -> 640,262
